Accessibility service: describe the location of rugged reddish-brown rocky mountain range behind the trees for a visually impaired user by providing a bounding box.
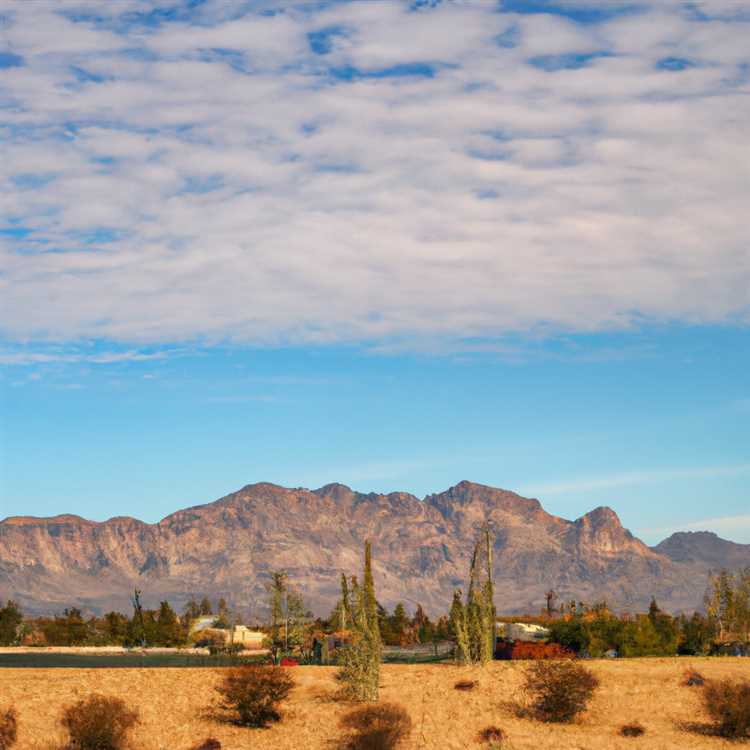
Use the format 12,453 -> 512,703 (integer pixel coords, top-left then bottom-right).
0,482 -> 750,616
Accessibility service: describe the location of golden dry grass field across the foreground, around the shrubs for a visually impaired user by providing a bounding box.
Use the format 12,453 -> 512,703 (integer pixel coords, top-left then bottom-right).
0,658 -> 750,750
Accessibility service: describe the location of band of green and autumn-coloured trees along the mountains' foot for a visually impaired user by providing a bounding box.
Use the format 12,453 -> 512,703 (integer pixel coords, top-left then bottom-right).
0,560 -> 750,663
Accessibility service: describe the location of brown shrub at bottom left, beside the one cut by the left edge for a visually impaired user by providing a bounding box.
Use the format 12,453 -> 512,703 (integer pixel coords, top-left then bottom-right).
62,693 -> 138,750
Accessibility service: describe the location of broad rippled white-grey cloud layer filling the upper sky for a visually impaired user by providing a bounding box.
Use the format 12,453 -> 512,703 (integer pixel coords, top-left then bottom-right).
0,0 -> 750,343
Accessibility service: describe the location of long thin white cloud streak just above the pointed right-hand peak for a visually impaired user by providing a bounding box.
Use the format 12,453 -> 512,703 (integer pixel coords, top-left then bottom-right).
521,463 -> 750,497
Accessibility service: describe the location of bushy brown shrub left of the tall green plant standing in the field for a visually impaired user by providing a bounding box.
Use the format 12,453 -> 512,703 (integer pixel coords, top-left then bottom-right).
216,665 -> 294,727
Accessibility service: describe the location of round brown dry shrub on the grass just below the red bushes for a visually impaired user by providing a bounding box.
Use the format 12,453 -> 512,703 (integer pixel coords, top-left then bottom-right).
524,660 -> 599,722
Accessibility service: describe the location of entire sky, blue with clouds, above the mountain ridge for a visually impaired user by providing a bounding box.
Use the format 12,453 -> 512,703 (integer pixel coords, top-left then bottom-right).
0,0 -> 750,542
